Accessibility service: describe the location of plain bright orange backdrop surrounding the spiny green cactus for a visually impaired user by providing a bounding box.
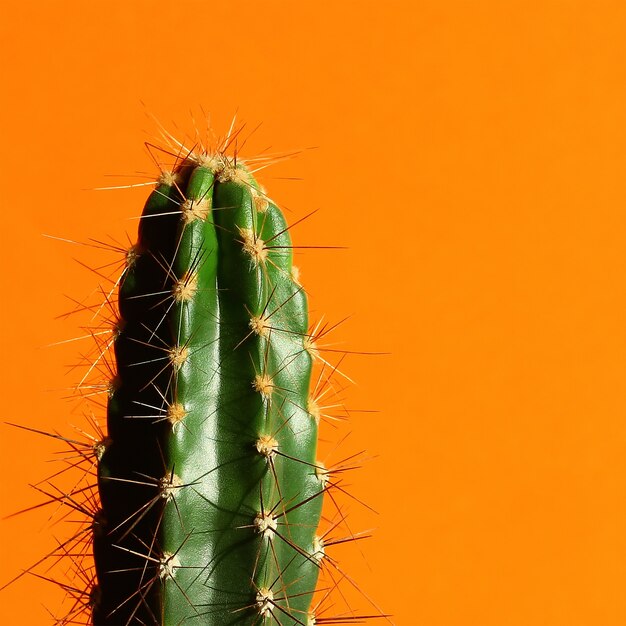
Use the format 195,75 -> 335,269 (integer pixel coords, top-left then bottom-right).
0,0 -> 626,626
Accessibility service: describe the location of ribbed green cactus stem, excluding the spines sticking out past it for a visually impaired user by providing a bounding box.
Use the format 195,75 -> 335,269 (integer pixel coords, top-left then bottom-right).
91,153 -> 326,626
